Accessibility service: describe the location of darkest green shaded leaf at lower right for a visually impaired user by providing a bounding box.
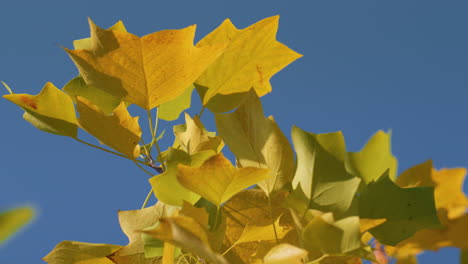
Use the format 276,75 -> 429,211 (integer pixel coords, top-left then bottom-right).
359,170 -> 441,246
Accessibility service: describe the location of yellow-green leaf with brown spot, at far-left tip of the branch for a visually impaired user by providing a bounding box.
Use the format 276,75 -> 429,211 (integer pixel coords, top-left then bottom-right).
3,82 -> 78,138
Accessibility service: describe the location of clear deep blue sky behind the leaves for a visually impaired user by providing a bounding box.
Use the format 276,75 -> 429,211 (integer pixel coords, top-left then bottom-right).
0,0 -> 468,263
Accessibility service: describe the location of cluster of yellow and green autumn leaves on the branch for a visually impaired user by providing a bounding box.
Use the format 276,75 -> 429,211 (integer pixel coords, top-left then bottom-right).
0,16 -> 468,264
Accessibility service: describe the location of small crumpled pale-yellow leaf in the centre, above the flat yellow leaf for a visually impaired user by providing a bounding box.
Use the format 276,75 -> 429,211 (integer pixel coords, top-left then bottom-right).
174,113 -> 224,154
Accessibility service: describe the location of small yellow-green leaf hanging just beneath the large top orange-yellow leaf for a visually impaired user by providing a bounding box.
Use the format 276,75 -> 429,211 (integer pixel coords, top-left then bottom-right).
158,84 -> 195,121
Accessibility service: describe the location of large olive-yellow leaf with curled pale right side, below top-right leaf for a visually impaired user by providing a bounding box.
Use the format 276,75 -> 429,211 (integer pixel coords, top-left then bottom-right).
215,90 -> 295,194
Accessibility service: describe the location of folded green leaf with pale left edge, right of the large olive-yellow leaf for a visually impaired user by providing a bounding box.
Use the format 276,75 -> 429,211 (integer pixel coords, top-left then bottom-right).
292,127 -> 361,218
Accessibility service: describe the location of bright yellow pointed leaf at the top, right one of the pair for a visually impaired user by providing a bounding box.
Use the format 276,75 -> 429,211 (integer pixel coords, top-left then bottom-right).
196,16 -> 302,109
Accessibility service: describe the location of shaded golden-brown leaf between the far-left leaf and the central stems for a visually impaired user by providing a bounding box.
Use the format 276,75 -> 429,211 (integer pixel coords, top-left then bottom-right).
76,97 -> 141,158
